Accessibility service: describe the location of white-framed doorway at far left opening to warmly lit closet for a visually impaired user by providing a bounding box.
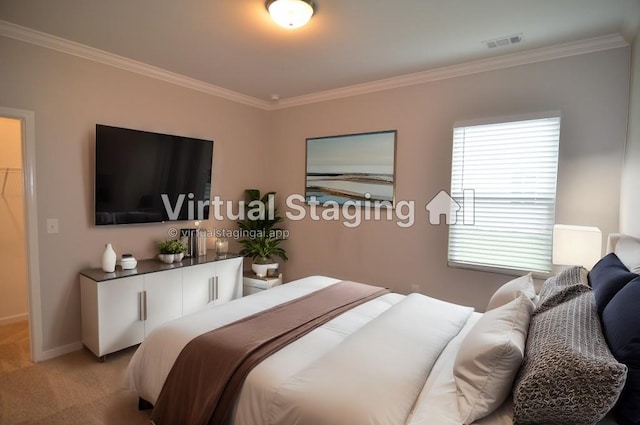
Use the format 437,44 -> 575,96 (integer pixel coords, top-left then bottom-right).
0,106 -> 44,362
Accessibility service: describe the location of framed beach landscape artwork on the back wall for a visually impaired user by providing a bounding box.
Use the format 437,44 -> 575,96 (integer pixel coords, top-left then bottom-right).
305,130 -> 397,207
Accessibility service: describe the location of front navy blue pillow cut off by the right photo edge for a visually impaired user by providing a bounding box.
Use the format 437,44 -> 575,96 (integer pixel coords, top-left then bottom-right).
602,277 -> 640,425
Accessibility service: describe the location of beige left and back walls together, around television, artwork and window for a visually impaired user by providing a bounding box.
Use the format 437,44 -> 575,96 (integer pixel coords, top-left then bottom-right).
0,33 -> 629,350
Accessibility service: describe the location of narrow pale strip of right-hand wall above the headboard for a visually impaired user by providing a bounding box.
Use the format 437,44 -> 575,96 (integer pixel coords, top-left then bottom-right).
620,35 -> 640,238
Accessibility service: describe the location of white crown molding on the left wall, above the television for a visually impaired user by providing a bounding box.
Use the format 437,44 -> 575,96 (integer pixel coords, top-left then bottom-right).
0,20 -> 270,109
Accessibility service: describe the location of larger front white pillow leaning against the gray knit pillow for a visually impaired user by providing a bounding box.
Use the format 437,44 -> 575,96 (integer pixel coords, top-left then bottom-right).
453,293 -> 534,425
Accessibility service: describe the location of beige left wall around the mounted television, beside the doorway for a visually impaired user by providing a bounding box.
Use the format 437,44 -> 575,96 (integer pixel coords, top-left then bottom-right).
0,37 -> 268,351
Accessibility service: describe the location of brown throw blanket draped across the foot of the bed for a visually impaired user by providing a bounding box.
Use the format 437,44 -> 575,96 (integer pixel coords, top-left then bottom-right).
151,282 -> 389,425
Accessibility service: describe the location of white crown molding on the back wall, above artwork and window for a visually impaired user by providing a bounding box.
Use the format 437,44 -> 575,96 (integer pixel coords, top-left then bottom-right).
269,34 -> 629,109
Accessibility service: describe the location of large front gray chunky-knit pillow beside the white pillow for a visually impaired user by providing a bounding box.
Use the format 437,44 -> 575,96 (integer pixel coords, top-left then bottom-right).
513,290 -> 627,425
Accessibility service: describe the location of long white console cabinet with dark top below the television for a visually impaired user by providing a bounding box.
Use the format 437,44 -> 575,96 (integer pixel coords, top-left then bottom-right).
80,252 -> 242,357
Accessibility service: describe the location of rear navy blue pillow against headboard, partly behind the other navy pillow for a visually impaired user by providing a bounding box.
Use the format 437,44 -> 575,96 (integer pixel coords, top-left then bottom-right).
589,252 -> 638,315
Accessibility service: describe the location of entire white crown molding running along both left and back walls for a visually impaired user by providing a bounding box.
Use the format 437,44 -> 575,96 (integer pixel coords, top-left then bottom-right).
0,20 -> 629,110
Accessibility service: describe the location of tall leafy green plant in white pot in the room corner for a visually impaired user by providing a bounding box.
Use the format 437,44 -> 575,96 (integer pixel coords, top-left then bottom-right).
238,189 -> 289,276
